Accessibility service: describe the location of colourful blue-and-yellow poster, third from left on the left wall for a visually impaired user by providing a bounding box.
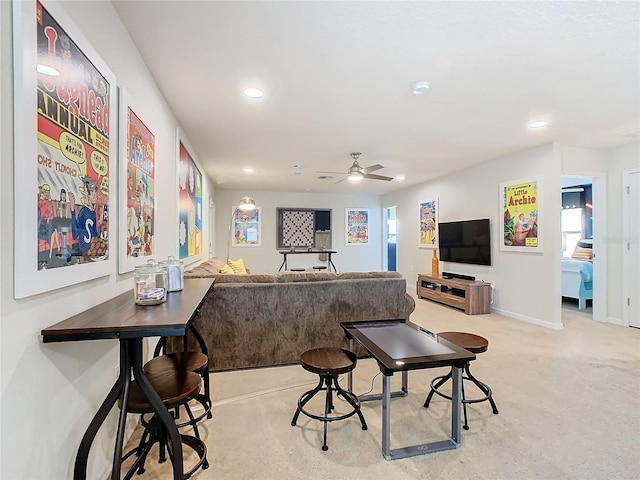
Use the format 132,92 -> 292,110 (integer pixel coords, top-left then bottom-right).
177,130 -> 203,263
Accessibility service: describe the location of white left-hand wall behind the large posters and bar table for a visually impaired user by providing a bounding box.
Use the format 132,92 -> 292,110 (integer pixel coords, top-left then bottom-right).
0,1 -> 212,480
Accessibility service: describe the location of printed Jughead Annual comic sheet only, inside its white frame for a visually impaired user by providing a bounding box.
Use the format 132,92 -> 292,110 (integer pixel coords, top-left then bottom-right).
35,2 -> 112,270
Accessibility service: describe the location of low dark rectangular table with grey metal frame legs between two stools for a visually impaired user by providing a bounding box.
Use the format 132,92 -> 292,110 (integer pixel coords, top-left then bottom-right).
340,319 -> 476,460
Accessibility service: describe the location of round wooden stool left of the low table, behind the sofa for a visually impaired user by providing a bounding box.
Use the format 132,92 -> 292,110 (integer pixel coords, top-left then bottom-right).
291,348 -> 367,451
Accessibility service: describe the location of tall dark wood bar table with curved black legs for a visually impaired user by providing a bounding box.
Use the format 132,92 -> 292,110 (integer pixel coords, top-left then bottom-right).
41,278 -> 215,480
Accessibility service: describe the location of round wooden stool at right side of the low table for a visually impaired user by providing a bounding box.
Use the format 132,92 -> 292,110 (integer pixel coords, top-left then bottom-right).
424,332 -> 498,430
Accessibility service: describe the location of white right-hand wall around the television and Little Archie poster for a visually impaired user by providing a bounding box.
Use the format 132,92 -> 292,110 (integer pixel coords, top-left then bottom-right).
382,144 -> 562,329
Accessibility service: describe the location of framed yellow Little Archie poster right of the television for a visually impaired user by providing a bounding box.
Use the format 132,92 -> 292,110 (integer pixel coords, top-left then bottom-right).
500,177 -> 543,253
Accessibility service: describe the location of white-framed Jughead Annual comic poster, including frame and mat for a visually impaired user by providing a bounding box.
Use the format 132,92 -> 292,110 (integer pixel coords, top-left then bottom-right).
13,1 -> 117,298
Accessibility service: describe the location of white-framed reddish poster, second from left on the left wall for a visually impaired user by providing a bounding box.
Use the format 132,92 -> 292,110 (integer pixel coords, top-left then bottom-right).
118,88 -> 156,273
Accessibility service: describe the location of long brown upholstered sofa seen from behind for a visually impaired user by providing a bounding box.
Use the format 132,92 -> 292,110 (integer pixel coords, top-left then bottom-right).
169,259 -> 415,371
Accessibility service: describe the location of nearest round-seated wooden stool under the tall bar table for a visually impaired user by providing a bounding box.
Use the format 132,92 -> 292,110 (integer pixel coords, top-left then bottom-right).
120,370 -> 209,480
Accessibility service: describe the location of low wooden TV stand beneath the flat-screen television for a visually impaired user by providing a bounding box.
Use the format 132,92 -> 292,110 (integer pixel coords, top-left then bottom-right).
417,275 -> 491,315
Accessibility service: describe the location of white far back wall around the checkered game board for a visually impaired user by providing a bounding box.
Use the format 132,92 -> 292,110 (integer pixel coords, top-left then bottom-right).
214,189 -> 382,273
